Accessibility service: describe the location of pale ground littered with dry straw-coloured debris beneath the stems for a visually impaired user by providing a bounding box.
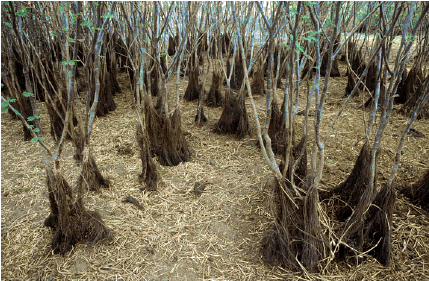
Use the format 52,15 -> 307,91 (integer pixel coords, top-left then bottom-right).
1,48 -> 429,280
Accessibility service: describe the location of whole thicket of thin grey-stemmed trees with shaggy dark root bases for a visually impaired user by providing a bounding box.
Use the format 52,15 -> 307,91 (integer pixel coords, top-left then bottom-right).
1,1 -> 429,272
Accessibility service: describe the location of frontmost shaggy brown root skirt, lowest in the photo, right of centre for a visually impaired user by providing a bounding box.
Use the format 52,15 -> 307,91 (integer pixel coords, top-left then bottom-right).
261,138 -> 329,273
